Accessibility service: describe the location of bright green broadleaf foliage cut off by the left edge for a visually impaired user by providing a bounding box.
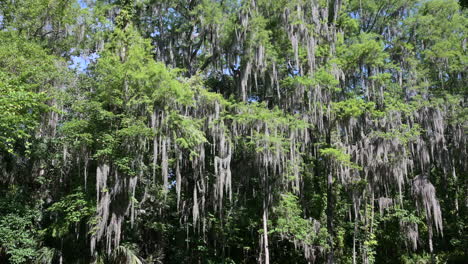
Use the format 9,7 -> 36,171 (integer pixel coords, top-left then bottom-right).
0,32 -> 62,153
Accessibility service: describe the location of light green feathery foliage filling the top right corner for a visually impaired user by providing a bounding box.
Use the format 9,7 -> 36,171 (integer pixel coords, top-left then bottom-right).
405,0 -> 468,91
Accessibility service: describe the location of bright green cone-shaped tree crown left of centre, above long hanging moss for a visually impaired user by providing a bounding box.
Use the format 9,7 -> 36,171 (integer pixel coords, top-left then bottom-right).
84,27 -> 198,167
